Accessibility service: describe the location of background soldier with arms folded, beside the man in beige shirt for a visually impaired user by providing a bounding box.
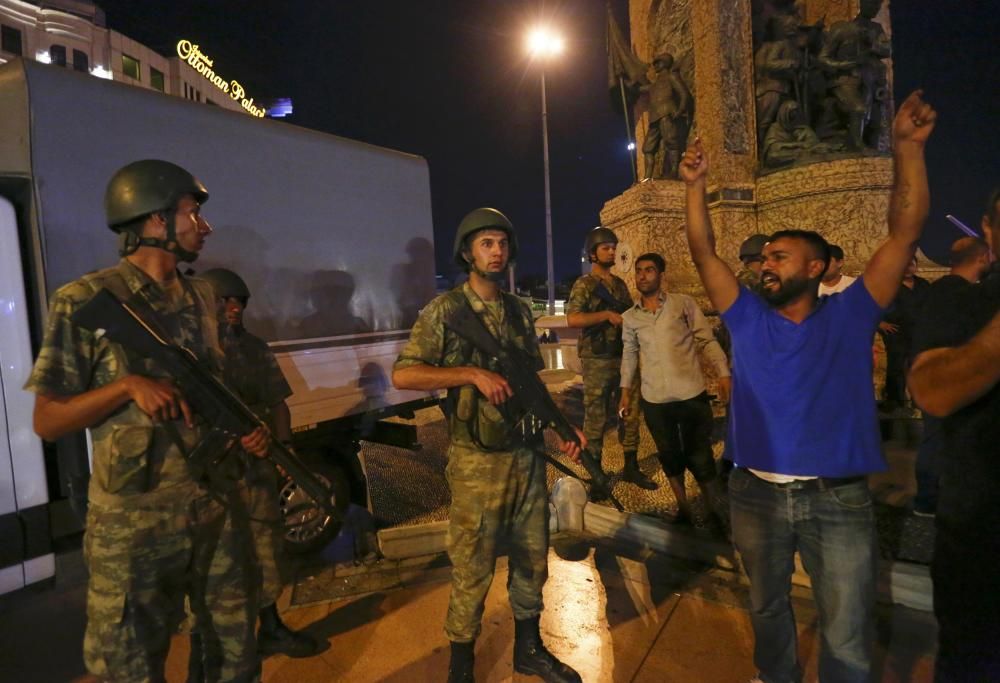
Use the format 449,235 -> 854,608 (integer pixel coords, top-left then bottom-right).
566,227 -> 656,500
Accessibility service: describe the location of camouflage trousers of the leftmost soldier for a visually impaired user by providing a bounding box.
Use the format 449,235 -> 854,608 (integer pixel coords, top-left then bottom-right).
83,487 -> 260,683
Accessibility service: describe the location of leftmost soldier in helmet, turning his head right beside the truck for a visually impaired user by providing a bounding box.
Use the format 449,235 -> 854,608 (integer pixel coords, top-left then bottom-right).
26,160 -> 270,682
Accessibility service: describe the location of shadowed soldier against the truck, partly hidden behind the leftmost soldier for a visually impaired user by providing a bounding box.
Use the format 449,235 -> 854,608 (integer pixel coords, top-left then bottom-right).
197,268 -> 319,668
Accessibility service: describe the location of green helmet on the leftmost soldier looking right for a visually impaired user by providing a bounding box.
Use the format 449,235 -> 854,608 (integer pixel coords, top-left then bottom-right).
104,159 -> 208,232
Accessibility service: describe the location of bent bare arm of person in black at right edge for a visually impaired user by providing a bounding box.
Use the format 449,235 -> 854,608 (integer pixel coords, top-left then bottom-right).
908,313 -> 1000,417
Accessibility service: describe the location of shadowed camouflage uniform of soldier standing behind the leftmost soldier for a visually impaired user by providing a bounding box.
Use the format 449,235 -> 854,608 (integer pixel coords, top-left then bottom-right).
219,326 -> 292,606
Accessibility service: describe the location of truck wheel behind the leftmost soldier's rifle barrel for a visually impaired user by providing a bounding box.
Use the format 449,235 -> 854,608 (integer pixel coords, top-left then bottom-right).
278,457 -> 351,555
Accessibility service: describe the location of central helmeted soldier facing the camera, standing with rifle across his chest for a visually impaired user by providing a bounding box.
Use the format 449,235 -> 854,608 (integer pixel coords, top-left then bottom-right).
392,208 -> 585,683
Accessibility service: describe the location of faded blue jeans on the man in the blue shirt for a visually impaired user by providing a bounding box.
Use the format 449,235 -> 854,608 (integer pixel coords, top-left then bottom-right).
729,468 -> 877,683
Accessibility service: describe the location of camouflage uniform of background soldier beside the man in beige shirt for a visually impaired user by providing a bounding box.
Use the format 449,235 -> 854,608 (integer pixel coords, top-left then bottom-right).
566,274 -> 640,461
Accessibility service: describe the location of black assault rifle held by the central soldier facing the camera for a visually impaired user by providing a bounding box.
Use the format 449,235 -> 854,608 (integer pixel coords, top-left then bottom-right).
444,304 -> 624,510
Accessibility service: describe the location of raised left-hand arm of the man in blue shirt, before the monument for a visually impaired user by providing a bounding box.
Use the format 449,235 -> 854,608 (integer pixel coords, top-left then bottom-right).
679,138 -> 740,313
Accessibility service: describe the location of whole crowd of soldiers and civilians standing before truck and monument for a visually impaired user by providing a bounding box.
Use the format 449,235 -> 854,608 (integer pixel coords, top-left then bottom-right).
27,92 -> 1000,683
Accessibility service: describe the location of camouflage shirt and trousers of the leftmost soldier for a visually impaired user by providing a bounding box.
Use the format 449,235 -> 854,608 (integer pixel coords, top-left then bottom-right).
25,260 -> 259,681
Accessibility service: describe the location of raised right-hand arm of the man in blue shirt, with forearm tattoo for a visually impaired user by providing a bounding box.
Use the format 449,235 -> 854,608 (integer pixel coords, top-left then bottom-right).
862,90 -> 937,308
